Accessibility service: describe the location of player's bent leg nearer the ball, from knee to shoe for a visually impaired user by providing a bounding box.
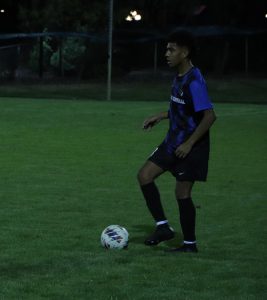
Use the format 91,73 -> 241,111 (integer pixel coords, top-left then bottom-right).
137,160 -> 174,246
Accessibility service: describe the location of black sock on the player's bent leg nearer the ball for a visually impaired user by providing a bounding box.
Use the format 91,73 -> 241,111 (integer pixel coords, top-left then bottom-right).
141,182 -> 166,222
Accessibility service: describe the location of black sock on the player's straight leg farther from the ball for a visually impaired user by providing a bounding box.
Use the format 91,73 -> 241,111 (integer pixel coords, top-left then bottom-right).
177,198 -> 196,242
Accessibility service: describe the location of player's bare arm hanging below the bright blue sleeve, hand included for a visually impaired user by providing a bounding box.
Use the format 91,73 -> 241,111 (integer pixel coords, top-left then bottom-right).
175,109 -> 216,158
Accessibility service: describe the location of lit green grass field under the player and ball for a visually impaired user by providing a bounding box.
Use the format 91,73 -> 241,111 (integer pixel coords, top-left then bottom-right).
0,98 -> 267,300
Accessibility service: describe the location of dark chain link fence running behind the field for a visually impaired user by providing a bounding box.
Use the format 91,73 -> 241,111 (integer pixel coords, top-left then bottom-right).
0,28 -> 267,81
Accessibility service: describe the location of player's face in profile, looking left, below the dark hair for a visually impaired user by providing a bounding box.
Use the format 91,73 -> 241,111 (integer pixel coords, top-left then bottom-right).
165,43 -> 188,67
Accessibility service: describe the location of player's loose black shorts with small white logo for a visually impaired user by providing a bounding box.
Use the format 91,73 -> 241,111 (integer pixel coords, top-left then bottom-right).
148,141 -> 209,182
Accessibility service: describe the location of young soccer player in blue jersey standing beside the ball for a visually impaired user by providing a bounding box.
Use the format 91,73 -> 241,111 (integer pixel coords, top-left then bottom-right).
138,31 -> 216,253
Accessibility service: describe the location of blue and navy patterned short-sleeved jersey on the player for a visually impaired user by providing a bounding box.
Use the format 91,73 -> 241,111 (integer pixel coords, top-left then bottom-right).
164,67 -> 213,153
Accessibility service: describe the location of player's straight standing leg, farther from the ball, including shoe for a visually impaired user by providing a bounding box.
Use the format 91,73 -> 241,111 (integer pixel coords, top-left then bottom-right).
168,181 -> 198,252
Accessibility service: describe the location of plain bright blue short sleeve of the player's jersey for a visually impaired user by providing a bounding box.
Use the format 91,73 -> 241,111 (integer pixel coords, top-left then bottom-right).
189,80 -> 213,112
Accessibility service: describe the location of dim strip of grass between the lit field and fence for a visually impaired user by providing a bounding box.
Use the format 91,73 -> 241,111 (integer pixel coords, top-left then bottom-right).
0,78 -> 267,104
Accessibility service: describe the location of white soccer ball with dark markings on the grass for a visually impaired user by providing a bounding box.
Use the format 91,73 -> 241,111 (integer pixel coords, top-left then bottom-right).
101,225 -> 129,249
